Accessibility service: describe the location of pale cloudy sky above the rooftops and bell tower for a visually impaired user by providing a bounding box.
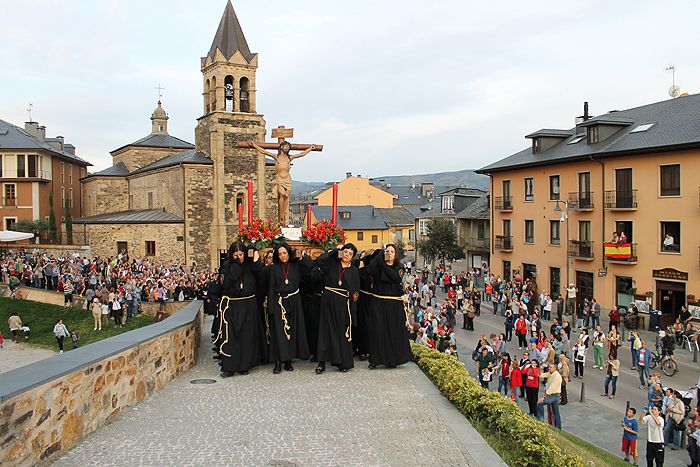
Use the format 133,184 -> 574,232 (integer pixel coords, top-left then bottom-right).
0,0 -> 700,181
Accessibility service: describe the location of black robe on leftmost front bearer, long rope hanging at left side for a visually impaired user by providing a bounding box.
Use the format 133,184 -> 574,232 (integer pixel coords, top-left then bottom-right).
218,261 -> 267,371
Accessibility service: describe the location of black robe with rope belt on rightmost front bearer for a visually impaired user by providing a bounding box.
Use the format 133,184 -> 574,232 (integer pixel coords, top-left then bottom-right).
367,255 -> 412,366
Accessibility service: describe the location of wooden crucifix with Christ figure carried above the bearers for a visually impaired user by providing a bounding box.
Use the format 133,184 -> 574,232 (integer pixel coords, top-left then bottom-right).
238,125 -> 323,226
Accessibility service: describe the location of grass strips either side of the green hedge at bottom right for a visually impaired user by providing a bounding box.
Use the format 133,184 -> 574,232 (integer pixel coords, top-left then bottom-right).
474,418 -> 628,467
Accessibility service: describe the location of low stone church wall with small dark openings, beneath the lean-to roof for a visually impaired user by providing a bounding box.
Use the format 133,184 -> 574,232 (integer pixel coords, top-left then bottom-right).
80,224 -> 185,261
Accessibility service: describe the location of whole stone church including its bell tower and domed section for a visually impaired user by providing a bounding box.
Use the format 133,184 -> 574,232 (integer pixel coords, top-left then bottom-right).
74,1 -> 277,268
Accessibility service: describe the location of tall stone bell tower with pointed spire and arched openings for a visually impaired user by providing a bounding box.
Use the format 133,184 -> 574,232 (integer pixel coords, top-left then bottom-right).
195,0 -> 277,264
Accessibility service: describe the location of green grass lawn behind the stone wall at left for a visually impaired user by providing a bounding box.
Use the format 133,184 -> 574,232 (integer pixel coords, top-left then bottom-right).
0,297 -> 154,351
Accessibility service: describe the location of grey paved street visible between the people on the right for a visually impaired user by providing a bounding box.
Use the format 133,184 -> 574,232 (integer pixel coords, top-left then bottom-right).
457,305 -> 700,465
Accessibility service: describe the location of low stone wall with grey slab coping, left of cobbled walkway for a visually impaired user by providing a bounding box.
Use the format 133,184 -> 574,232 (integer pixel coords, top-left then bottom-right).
0,302 -> 203,466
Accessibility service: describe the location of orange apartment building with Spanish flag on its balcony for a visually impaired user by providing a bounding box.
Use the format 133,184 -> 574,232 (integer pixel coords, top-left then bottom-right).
477,95 -> 700,324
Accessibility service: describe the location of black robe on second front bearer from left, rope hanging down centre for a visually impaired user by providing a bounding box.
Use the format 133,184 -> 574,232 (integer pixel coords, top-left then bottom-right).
265,260 -> 309,362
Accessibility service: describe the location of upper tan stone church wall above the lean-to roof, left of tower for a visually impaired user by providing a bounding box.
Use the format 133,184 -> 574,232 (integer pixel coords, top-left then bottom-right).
128,166 -> 184,216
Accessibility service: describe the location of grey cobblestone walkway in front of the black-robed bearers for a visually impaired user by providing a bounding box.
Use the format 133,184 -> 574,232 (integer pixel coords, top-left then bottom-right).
54,316 -> 492,466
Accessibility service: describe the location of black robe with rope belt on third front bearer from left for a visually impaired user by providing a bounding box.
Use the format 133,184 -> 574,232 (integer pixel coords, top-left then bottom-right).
316,249 -> 360,369
